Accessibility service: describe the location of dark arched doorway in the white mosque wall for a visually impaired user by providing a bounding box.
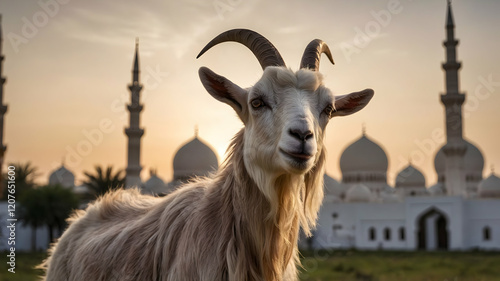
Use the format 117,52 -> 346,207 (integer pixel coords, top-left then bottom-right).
417,208 -> 449,250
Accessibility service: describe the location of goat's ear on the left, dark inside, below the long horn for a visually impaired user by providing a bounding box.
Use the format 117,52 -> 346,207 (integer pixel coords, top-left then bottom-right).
198,67 -> 248,122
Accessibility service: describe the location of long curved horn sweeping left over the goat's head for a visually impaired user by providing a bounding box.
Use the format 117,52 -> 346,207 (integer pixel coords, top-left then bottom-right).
196,29 -> 285,70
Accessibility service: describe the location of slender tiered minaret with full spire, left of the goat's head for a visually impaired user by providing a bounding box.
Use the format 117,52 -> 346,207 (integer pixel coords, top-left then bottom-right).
125,39 -> 144,188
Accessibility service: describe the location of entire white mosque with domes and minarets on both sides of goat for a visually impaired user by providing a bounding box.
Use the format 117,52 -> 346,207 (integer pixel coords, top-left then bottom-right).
0,3 -> 500,250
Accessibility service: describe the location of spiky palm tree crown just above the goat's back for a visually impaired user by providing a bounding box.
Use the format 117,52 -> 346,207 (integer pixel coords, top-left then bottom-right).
83,166 -> 125,197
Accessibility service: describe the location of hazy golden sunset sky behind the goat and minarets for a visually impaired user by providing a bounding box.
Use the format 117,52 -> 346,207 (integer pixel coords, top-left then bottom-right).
0,0 -> 500,186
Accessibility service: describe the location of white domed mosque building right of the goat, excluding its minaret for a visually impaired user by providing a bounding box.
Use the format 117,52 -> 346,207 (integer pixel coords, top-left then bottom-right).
314,130 -> 500,250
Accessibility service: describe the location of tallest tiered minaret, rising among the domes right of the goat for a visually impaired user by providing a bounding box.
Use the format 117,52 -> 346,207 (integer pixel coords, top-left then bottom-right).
441,0 -> 467,195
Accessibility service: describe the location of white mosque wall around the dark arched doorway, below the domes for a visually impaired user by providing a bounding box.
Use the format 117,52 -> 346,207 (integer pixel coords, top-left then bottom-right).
313,196 -> 500,250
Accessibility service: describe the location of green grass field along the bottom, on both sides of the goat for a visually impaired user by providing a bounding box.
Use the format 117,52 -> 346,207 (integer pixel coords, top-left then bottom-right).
0,248 -> 500,281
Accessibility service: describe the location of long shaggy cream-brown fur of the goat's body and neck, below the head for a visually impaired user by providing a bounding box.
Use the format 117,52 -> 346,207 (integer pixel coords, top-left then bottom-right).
43,129 -> 325,281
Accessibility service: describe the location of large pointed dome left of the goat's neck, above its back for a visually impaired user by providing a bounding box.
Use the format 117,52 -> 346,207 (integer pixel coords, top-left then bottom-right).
174,136 -> 219,180
